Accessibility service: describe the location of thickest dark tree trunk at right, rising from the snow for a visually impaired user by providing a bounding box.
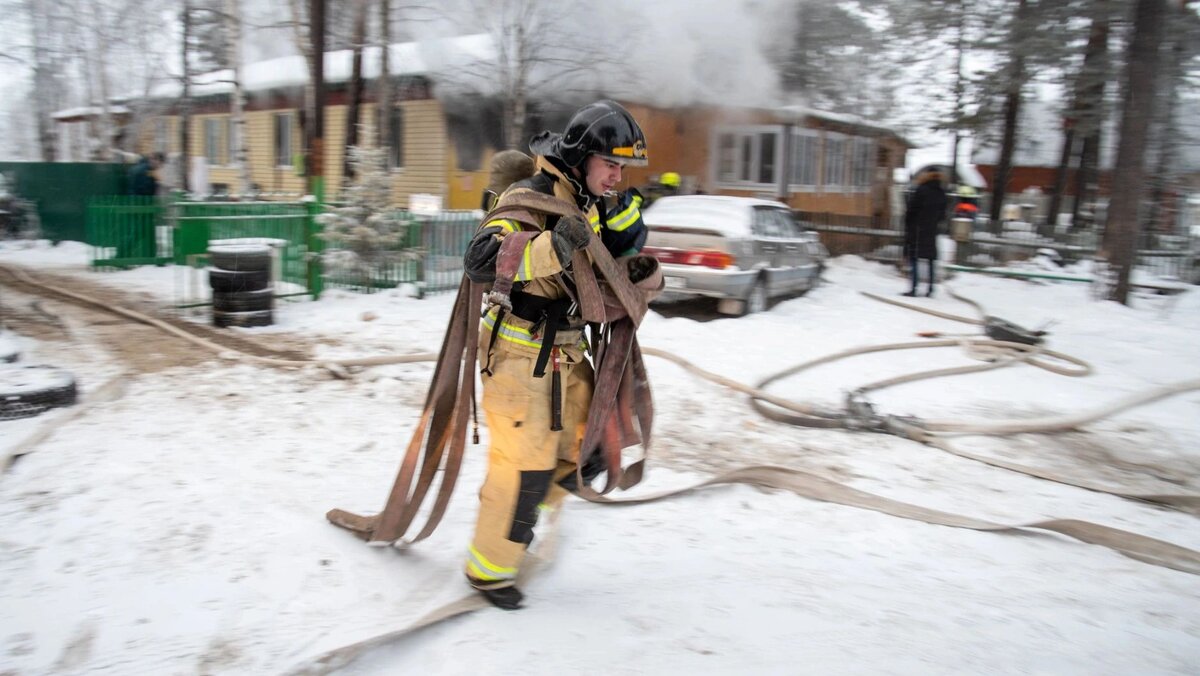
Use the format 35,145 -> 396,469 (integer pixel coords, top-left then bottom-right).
1100,0 -> 1165,304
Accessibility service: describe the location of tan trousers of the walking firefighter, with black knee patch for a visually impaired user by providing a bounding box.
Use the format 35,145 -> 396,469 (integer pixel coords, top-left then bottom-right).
466,328 -> 594,590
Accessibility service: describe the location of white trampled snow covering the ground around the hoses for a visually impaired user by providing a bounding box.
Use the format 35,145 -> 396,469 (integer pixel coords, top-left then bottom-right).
0,243 -> 1200,675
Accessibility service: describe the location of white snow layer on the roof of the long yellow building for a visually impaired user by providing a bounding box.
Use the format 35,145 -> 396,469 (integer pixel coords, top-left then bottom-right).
150,34 -> 496,98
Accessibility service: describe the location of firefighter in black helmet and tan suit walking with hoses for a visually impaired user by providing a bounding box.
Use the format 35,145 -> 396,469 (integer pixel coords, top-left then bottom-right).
464,101 -> 647,610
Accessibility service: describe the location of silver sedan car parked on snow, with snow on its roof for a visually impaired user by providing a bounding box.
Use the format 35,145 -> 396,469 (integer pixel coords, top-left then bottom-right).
642,195 -> 828,315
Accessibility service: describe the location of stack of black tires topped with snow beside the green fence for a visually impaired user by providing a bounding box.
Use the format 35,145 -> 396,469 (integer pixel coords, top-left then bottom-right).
209,244 -> 275,328
